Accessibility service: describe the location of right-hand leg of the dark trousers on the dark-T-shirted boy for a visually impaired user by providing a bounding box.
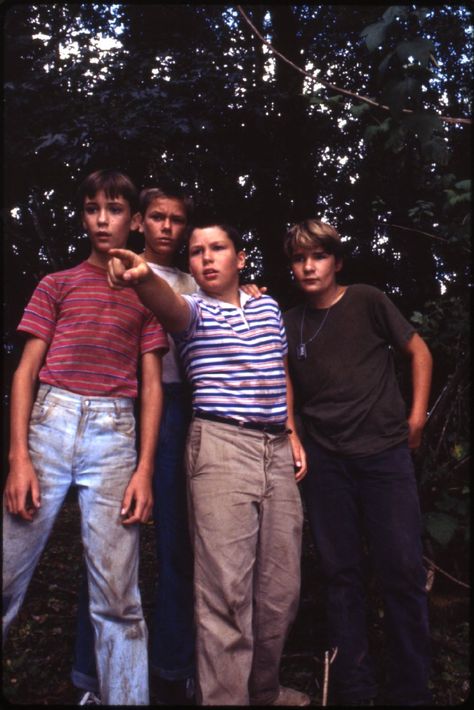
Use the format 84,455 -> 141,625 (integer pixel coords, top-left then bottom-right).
355,444 -> 431,705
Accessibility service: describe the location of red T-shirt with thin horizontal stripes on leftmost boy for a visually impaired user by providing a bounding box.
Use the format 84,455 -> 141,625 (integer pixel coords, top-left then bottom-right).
18,261 -> 168,397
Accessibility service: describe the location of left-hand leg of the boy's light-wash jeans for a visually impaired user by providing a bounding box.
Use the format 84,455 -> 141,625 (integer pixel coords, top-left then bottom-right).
3,385 -> 76,640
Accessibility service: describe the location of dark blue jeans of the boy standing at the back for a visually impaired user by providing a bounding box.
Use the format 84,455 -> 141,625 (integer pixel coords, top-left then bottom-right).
71,384 -> 195,691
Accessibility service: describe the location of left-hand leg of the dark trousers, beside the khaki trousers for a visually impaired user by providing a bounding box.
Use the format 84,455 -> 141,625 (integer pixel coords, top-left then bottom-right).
302,438 -> 377,703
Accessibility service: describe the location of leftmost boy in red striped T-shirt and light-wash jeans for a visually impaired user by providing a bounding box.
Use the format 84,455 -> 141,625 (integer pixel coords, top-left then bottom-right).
3,170 -> 168,705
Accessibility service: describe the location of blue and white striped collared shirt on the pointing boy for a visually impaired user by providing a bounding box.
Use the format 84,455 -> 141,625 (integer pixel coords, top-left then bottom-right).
174,290 -> 288,424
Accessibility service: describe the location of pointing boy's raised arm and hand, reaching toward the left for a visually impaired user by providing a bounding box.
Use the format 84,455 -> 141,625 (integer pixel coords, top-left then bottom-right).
108,249 -> 190,333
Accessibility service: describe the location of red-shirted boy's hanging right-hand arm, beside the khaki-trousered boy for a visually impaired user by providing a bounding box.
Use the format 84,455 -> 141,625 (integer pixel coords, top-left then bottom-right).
120,351 -> 163,525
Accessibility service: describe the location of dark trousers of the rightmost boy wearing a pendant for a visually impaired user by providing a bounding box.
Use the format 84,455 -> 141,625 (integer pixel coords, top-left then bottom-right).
302,438 -> 430,705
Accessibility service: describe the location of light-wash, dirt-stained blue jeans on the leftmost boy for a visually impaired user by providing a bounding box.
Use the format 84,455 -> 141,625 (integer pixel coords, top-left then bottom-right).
3,385 -> 149,705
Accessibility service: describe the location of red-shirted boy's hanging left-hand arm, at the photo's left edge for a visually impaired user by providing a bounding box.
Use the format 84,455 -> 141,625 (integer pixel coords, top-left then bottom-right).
5,337 -> 48,520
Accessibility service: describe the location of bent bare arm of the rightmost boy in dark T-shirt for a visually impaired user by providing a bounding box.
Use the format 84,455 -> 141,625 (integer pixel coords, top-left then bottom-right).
405,333 -> 433,449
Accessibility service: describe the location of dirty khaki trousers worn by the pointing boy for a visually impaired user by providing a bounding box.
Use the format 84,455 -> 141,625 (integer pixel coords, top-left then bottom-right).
186,419 -> 303,705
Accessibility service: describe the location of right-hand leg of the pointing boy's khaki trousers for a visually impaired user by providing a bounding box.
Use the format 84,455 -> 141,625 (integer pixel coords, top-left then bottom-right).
250,435 -> 303,705
